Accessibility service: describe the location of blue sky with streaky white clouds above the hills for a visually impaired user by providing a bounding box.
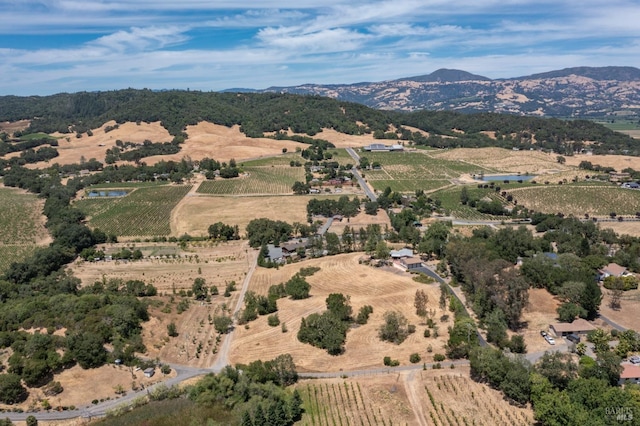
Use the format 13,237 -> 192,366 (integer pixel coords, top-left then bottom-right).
0,0 -> 640,95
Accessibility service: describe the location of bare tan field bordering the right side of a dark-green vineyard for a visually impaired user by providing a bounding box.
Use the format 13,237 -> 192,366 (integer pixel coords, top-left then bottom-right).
171,195 -> 335,236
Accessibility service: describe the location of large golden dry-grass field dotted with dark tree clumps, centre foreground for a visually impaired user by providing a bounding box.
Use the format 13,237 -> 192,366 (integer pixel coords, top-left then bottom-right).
229,253 -> 452,371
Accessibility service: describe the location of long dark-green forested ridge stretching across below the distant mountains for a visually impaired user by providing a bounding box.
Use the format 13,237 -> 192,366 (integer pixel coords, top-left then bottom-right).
0,89 -> 640,155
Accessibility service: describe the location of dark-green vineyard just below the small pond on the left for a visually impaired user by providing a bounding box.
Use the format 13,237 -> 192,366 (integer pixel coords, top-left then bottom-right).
74,185 -> 191,237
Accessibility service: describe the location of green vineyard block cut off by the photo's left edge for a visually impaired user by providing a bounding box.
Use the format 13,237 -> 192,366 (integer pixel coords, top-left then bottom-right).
0,186 -> 51,273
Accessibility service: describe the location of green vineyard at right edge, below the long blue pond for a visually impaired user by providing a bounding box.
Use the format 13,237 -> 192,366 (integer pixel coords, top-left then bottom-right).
509,184 -> 640,217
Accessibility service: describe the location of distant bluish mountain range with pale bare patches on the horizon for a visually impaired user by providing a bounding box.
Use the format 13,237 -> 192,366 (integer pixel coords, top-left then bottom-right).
245,67 -> 640,118
